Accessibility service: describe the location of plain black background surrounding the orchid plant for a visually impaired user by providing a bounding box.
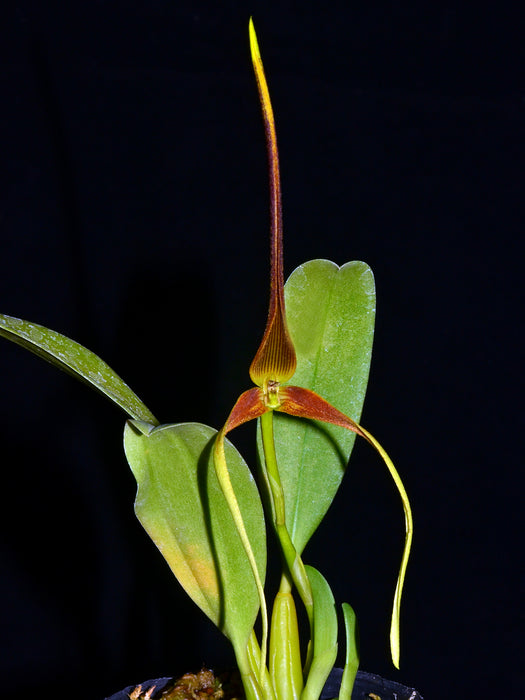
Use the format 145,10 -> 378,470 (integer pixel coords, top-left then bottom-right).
0,0 -> 525,700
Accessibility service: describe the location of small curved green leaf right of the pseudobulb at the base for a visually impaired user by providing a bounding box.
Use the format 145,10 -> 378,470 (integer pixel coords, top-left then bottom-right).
301,566 -> 337,700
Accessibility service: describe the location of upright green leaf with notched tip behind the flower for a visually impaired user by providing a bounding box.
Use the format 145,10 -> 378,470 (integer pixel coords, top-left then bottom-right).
259,260 -> 375,553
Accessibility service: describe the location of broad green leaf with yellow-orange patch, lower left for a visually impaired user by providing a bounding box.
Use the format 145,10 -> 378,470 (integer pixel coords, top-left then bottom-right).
124,421 -> 266,655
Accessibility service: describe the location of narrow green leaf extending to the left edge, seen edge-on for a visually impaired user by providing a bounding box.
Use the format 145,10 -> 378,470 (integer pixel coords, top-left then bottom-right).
0,314 -> 158,425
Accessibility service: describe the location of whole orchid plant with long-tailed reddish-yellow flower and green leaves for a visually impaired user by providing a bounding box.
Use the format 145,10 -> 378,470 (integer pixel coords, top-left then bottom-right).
0,20 -> 412,700
